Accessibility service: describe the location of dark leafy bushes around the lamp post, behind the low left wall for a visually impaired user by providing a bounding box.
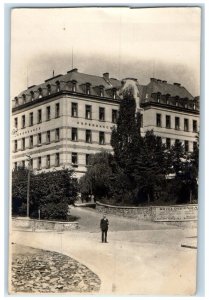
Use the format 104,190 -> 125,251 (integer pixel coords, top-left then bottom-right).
12,167 -> 77,220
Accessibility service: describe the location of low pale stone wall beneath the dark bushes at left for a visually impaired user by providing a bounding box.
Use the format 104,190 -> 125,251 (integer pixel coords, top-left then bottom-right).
12,218 -> 79,231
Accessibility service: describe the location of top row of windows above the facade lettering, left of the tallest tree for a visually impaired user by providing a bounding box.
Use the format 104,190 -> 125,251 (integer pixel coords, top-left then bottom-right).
14,103 -> 118,128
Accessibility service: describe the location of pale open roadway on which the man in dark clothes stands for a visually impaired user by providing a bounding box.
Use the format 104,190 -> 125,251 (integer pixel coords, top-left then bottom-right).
11,208 -> 196,295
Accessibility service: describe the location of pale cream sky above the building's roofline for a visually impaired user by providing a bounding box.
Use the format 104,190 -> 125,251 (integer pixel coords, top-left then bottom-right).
11,7 -> 201,98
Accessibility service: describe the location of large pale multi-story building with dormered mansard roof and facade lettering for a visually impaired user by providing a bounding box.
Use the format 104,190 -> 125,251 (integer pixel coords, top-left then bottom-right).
12,69 -> 199,177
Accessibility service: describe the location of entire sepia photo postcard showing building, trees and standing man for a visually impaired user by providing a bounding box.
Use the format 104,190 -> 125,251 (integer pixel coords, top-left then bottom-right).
8,6 -> 201,296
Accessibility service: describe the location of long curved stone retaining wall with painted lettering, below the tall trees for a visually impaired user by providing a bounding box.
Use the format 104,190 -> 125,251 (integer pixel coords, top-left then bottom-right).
96,202 -> 198,223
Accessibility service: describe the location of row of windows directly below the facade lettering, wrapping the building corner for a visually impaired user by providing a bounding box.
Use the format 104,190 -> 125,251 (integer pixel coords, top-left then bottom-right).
14,128 -> 105,152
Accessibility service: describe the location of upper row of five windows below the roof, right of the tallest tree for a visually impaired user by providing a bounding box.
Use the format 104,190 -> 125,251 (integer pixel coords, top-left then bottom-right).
156,114 -> 197,132
